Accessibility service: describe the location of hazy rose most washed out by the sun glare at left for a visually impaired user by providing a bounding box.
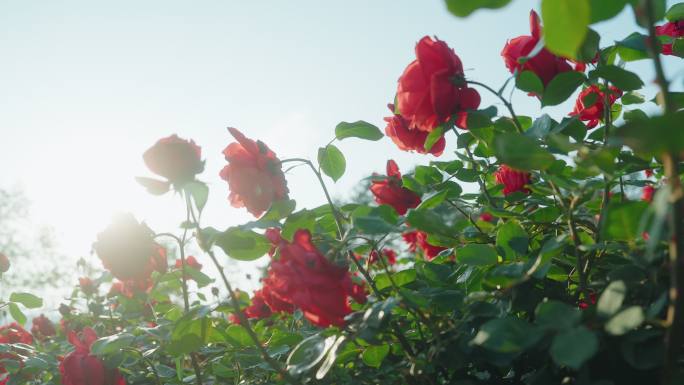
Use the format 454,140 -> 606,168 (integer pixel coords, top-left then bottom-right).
93,214 -> 167,287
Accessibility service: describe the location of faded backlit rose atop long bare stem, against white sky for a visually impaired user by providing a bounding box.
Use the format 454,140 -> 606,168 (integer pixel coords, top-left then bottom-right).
143,135 -> 204,184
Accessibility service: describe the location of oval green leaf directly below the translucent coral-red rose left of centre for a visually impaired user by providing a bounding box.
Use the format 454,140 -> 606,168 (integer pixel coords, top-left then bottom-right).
215,227 -> 271,261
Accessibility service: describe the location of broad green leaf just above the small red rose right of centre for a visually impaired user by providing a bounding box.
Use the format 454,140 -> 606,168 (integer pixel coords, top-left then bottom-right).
494,133 -> 555,171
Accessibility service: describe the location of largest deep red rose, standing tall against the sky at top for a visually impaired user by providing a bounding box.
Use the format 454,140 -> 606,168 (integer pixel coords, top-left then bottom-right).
397,36 -> 480,132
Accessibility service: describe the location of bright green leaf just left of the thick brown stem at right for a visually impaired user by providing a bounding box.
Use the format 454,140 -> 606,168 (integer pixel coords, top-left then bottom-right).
602,201 -> 648,241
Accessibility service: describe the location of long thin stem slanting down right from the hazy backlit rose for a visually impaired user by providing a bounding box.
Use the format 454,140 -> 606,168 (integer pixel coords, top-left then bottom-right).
184,200 -> 302,385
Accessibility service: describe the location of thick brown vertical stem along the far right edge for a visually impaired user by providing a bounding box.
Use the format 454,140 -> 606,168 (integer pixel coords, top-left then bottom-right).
645,0 -> 684,384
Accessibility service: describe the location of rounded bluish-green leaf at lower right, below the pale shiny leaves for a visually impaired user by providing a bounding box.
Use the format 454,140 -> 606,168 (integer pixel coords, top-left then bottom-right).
549,326 -> 599,369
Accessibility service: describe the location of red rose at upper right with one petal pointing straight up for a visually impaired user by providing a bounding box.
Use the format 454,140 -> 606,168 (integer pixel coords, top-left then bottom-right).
501,11 -> 586,90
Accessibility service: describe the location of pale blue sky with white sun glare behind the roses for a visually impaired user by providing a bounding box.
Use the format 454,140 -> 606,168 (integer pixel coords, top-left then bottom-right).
0,0 -> 681,270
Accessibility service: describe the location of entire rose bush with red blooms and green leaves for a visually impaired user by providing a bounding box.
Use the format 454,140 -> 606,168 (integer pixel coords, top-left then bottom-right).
0,0 -> 684,385
